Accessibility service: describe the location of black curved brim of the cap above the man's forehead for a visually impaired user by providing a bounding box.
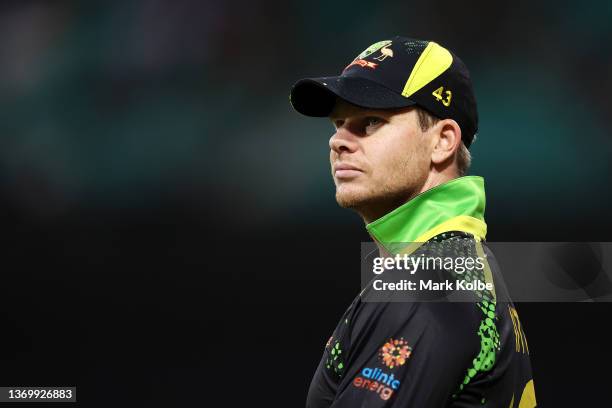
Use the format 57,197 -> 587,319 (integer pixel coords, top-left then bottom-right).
291,76 -> 415,117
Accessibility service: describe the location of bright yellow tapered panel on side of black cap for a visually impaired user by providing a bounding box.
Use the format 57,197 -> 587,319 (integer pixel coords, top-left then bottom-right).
402,41 -> 453,97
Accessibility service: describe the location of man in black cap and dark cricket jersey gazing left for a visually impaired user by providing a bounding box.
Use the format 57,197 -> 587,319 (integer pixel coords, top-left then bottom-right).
290,37 -> 536,408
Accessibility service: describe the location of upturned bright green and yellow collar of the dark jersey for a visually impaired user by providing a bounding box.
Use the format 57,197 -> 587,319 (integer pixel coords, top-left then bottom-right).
366,176 -> 487,250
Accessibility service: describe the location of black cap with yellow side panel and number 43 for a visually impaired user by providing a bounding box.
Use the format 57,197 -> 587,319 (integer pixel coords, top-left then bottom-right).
290,36 -> 478,147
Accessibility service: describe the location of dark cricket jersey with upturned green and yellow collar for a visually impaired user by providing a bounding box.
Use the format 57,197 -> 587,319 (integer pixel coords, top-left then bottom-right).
306,176 -> 536,408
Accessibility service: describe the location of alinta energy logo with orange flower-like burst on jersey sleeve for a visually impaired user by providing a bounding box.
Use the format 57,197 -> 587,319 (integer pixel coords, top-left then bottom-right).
353,338 -> 412,401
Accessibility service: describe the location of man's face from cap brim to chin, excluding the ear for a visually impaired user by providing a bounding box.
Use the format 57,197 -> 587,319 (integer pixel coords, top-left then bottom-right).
329,99 -> 432,222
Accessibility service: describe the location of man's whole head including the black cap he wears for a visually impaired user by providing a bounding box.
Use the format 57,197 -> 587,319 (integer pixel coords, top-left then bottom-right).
291,37 -> 478,221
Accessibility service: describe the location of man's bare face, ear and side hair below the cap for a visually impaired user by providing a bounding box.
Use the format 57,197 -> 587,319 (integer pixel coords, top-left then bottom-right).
329,99 -> 469,222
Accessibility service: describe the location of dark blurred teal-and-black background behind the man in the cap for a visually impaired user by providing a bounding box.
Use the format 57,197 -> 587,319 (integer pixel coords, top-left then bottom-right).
0,0 -> 612,407
